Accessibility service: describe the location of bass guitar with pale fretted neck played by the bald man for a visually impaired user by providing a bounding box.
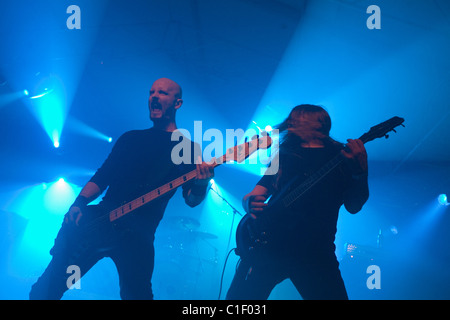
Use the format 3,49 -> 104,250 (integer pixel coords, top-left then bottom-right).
55,133 -> 272,253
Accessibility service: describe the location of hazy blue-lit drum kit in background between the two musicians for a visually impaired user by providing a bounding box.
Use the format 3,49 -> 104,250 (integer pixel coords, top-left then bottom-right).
153,216 -> 218,299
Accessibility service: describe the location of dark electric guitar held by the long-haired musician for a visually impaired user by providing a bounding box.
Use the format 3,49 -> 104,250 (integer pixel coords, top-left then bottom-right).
236,117 -> 404,258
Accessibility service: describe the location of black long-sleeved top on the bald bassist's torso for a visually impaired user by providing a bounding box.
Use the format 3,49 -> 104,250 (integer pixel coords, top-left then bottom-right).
90,128 -> 199,233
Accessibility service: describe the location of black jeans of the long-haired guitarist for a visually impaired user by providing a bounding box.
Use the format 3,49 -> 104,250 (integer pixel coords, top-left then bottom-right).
226,253 -> 348,300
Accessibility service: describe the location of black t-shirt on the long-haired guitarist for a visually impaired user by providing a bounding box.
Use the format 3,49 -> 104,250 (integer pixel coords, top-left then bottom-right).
258,144 -> 351,258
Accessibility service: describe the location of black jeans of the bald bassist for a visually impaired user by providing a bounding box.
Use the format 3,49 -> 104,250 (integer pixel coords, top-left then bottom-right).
30,214 -> 155,300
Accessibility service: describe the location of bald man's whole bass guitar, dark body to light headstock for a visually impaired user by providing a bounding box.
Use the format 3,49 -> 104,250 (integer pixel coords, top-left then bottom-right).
45,134 -> 272,263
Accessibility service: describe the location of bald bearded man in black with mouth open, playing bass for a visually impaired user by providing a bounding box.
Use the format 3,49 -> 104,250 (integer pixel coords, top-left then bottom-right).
30,78 -> 213,300
